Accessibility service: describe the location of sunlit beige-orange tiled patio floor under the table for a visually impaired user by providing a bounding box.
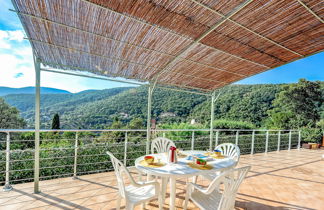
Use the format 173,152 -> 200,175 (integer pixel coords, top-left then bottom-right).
0,150 -> 324,210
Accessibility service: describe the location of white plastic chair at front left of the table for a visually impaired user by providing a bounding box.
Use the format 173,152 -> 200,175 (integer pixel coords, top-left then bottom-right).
107,152 -> 163,210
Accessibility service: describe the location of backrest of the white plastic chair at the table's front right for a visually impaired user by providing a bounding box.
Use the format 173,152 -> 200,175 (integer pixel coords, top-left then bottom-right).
205,166 -> 251,210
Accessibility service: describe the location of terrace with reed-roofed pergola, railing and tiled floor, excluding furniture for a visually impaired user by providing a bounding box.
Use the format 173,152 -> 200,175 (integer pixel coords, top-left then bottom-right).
0,0 -> 324,209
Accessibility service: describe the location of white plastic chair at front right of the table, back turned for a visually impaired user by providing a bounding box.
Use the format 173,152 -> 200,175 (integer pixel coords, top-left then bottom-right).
184,166 -> 251,210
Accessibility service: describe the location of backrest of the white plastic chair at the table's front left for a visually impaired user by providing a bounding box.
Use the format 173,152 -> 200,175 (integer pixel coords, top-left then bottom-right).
107,151 -> 134,197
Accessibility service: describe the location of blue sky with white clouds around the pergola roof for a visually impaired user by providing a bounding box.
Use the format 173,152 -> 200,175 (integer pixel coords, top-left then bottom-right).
0,0 -> 324,93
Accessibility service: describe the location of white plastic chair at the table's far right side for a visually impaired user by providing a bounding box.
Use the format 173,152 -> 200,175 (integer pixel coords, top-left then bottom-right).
194,143 -> 240,183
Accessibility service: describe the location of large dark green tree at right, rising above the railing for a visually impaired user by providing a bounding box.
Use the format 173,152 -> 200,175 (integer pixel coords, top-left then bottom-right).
267,79 -> 323,129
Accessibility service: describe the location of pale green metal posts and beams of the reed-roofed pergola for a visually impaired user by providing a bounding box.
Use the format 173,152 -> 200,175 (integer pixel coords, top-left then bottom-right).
12,0 -> 323,193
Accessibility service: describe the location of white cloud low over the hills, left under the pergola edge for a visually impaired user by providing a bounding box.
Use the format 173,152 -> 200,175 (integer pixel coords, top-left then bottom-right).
0,30 -> 134,92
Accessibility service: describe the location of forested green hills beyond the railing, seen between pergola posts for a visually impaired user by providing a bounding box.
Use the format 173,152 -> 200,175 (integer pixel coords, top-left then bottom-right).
3,85 -> 290,129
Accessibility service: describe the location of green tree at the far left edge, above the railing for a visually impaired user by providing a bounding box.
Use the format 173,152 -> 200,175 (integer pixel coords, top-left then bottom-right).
0,98 -> 26,129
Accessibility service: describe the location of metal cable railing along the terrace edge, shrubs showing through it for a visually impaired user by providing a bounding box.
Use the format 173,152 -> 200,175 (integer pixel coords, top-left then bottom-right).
0,129 -> 301,191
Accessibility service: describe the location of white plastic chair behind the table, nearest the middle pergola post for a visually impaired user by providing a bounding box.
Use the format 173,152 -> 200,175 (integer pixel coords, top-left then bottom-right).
151,137 -> 175,200
